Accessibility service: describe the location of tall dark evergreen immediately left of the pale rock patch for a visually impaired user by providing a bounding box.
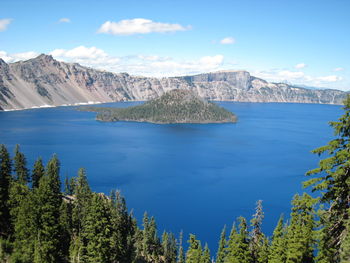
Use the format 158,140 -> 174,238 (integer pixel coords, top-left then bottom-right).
34,156 -> 64,263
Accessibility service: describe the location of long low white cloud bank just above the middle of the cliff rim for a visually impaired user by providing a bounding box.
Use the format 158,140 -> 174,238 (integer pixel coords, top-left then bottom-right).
50,46 -> 224,77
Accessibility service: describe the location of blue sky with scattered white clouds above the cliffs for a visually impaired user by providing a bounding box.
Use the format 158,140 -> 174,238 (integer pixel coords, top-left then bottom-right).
0,0 -> 350,90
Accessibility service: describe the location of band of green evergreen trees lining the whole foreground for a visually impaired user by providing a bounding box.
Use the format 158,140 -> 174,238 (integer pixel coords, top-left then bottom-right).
0,97 -> 350,263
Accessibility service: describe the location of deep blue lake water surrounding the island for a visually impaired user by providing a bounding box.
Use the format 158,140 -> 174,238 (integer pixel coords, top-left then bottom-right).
0,102 -> 342,254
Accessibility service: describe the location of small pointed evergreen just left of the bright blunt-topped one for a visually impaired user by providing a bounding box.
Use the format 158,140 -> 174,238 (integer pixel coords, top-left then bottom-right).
268,215 -> 287,263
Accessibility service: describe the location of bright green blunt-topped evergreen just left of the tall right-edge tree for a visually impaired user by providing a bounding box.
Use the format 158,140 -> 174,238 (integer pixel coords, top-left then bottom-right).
286,193 -> 315,263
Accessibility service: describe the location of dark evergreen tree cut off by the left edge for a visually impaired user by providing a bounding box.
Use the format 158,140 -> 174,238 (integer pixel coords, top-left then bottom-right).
0,144 -> 12,238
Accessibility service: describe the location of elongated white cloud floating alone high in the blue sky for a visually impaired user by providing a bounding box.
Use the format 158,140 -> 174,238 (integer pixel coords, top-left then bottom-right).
97,18 -> 191,35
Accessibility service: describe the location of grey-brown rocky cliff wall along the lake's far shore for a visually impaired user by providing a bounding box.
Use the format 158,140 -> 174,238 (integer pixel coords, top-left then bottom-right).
0,55 -> 346,110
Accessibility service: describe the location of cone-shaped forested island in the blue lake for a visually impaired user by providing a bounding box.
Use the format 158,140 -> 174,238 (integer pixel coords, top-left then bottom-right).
80,89 -> 237,124
